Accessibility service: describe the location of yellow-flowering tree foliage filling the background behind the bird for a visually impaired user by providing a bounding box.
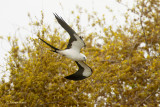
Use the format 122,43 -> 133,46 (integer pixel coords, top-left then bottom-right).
0,0 -> 160,107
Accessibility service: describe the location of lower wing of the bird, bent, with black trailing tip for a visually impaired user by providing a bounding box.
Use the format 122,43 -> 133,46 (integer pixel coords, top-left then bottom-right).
65,61 -> 92,81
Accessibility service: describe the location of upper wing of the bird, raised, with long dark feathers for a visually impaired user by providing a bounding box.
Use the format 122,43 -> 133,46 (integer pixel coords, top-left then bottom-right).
53,13 -> 85,52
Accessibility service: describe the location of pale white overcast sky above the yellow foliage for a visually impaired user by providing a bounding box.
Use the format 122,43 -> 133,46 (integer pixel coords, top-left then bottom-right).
0,0 -> 133,81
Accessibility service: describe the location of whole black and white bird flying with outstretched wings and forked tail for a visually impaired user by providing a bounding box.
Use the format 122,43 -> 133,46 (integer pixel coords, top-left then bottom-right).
39,14 -> 92,80
